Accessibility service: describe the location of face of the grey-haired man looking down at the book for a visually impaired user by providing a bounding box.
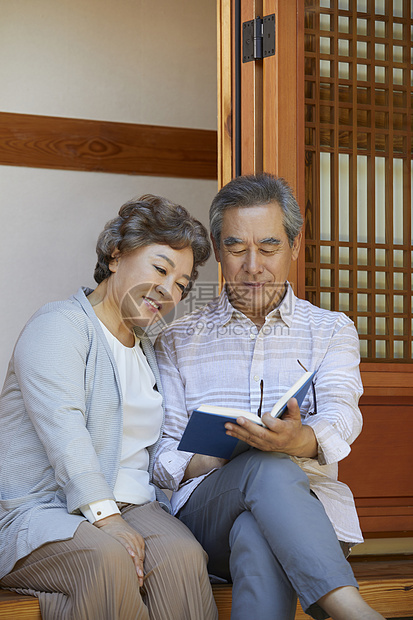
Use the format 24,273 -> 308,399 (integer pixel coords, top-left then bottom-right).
212,203 -> 301,325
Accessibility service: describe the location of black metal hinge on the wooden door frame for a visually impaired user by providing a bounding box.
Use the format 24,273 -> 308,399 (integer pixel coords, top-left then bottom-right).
242,13 -> 275,62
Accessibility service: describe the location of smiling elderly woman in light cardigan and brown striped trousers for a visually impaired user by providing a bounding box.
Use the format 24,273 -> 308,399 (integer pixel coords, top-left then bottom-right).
0,195 -> 217,620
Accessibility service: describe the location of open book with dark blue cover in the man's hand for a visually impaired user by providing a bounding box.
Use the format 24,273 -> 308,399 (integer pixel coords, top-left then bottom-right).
178,372 -> 315,459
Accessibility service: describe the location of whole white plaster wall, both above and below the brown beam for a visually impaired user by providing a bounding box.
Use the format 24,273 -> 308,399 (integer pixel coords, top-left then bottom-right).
0,0 -> 217,386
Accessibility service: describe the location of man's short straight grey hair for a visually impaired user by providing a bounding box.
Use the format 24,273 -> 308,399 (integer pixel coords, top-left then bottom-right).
209,172 -> 303,247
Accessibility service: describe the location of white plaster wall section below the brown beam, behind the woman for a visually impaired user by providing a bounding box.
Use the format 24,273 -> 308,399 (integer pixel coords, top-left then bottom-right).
0,166 -> 217,382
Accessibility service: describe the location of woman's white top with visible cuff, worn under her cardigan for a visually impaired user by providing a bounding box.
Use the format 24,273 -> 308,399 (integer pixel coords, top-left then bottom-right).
80,321 -> 163,523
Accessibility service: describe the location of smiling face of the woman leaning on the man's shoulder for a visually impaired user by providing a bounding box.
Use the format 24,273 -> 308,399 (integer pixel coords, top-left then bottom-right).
108,244 -> 194,328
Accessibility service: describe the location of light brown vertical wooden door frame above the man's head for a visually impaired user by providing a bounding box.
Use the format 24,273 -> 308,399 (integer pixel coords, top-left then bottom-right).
217,0 -> 305,297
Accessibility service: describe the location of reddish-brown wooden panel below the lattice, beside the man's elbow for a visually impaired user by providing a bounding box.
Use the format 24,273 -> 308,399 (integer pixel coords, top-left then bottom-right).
339,397 -> 413,532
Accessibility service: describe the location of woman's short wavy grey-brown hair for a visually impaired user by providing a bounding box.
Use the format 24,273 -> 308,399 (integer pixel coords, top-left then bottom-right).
94,194 -> 211,297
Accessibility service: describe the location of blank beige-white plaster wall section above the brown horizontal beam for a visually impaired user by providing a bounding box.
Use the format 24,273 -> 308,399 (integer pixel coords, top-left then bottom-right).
0,0 -> 217,129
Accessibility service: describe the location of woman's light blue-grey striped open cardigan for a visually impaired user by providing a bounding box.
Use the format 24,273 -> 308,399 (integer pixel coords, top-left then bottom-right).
0,289 -> 168,578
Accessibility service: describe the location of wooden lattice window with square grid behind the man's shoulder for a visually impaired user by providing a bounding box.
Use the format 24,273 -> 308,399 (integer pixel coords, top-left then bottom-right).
305,0 -> 413,362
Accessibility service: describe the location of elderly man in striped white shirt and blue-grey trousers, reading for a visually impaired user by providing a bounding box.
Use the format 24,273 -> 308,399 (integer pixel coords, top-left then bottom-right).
155,174 -> 382,620
